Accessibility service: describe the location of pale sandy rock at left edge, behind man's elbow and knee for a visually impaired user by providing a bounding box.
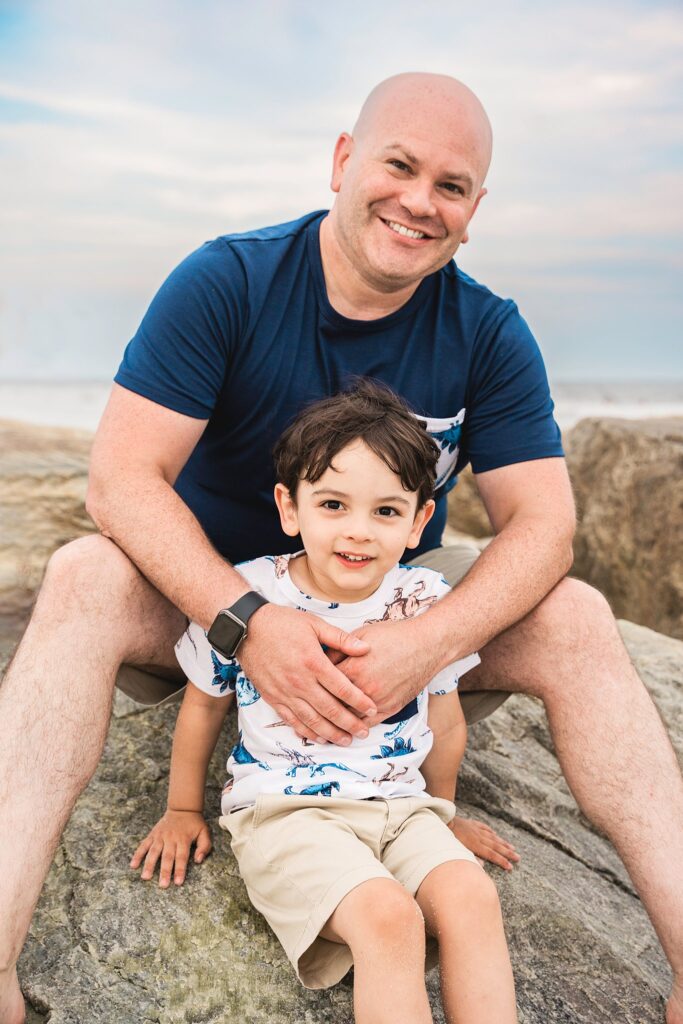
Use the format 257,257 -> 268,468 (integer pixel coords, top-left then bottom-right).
0,420 -> 95,630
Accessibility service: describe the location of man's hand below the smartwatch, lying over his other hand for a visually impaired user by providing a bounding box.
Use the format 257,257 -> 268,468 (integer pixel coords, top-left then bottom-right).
238,604 -> 377,745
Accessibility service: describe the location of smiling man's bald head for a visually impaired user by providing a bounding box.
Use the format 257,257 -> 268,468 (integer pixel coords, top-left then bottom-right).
330,73 -> 492,292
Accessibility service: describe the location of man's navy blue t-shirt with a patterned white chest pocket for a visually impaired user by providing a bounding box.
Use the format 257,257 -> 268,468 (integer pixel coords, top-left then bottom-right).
115,211 -> 562,562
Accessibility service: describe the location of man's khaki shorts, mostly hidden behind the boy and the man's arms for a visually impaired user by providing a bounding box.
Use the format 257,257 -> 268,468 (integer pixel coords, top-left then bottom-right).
116,544 -> 510,725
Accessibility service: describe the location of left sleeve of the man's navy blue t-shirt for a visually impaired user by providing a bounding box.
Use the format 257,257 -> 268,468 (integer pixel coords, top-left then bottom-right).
114,239 -> 247,420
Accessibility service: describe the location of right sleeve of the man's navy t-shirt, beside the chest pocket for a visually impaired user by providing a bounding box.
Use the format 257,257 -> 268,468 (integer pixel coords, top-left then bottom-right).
464,301 -> 564,473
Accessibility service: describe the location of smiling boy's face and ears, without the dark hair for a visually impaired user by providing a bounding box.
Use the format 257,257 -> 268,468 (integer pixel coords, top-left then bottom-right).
275,440 -> 434,602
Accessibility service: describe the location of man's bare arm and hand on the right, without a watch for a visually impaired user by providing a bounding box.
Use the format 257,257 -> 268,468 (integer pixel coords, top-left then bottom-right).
340,458 -> 575,721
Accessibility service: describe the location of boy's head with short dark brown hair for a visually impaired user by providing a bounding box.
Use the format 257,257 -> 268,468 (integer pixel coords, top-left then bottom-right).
273,380 -> 438,601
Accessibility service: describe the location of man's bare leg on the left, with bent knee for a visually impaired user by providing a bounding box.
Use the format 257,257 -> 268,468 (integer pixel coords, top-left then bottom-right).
0,537 -> 185,1024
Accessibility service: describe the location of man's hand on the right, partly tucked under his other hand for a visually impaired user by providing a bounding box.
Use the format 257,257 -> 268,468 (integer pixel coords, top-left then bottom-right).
331,614 -> 442,725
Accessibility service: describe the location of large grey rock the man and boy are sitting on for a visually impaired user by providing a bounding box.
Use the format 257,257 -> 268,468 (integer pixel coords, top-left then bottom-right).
10,623 -> 683,1024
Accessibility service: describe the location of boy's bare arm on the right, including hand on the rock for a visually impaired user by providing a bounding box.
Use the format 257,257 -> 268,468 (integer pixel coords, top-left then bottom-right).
420,690 -> 519,871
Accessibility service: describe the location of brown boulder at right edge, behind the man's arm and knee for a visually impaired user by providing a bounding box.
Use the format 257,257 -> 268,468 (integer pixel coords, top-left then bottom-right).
565,417 -> 683,637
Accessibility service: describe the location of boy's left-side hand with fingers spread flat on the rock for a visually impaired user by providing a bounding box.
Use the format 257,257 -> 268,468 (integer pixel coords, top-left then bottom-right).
130,810 -> 212,889
